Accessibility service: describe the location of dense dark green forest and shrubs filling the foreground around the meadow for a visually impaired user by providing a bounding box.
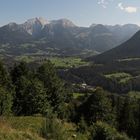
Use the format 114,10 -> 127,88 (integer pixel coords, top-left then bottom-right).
0,61 -> 140,140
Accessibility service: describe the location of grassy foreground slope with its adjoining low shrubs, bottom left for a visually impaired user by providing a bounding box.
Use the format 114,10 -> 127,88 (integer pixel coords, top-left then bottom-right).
0,116 -> 87,140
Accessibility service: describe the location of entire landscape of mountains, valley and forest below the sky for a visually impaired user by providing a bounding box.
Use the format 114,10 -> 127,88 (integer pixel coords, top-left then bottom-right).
0,18 -> 140,140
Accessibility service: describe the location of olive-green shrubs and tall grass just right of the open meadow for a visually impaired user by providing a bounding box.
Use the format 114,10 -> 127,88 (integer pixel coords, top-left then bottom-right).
42,117 -> 88,140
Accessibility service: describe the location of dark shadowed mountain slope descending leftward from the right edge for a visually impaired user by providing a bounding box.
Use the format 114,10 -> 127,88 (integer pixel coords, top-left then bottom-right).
89,31 -> 140,62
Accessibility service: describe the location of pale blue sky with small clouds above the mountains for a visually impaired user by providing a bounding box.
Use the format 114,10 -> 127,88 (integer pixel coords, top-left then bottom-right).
0,0 -> 140,27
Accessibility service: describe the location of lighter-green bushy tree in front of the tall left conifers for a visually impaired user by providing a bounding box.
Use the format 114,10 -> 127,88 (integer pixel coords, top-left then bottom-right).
26,79 -> 50,114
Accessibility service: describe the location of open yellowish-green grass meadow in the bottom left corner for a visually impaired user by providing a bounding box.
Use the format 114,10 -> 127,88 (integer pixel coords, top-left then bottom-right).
0,117 -> 44,140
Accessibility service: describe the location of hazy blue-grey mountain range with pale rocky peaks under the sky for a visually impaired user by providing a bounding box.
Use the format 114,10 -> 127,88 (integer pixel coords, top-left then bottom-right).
0,18 -> 140,55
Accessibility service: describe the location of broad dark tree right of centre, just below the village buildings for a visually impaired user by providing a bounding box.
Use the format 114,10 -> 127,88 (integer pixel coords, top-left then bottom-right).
80,88 -> 115,124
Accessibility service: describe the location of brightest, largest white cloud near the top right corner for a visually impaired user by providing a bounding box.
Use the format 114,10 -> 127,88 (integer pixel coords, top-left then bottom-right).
118,3 -> 138,13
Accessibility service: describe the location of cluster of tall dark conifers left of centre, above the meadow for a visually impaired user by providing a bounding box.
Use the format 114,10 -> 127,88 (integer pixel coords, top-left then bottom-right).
11,61 -> 68,118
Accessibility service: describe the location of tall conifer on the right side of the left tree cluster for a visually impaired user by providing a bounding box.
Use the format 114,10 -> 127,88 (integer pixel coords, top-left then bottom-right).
37,61 -> 67,115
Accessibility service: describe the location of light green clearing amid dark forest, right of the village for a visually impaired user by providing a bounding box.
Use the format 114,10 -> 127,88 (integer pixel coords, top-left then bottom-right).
105,72 -> 133,83
